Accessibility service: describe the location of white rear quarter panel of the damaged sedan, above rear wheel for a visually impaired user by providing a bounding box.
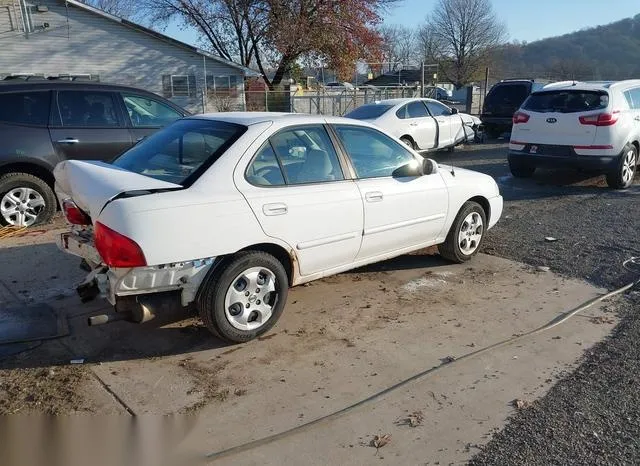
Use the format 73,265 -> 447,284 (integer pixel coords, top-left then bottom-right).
97,120 -> 278,265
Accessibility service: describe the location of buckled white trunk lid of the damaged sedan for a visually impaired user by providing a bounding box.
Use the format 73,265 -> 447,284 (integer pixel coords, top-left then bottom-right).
54,160 -> 182,220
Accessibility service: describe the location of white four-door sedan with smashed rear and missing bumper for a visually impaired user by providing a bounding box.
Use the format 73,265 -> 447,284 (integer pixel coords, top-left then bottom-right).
55,113 -> 502,342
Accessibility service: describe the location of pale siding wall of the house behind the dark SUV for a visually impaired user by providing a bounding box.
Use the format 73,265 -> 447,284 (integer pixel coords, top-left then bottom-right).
0,0 -> 248,112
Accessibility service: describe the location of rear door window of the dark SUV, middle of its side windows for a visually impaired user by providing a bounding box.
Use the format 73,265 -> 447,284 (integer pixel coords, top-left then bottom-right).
58,91 -> 119,128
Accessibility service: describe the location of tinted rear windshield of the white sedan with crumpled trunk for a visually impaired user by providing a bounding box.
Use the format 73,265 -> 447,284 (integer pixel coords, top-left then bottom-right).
112,119 -> 247,186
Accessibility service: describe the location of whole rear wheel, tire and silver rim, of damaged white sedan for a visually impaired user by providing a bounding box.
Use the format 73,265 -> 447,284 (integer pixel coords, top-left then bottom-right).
198,251 -> 289,343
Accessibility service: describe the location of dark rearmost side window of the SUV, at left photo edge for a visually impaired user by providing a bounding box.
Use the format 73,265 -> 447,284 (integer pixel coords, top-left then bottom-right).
0,91 -> 51,126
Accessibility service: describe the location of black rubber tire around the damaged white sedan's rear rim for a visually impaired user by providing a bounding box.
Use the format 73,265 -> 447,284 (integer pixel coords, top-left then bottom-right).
197,251 -> 289,343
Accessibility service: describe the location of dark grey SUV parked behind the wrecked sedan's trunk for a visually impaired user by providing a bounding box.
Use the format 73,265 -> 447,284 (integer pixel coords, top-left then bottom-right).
0,81 -> 188,226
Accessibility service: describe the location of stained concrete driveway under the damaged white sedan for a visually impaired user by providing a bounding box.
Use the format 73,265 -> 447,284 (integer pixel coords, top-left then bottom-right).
0,217 -> 616,464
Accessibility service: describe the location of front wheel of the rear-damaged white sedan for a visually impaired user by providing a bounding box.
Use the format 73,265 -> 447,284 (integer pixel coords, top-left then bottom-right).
438,201 -> 487,264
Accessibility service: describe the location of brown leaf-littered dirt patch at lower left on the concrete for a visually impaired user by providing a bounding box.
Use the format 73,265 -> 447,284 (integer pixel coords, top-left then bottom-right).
0,366 -> 94,415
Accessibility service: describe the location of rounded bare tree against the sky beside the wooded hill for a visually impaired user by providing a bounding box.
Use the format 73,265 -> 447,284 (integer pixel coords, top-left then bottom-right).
421,0 -> 506,88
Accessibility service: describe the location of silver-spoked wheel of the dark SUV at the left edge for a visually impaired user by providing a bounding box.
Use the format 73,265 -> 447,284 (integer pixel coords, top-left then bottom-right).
0,173 -> 56,227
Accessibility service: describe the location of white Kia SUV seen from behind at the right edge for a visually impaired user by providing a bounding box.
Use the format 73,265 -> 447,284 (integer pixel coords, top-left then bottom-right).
509,80 -> 640,189
